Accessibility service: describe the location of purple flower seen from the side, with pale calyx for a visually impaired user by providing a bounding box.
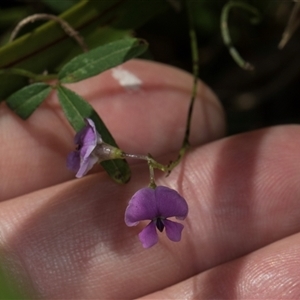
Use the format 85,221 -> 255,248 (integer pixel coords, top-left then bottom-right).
67,118 -> 122,178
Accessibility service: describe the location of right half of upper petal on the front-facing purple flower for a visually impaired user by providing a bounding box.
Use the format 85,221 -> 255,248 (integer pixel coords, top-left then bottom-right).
155,186 -> 188,220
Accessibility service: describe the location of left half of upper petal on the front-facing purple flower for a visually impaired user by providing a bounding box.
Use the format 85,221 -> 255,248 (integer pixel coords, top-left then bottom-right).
125,187 -> 158,226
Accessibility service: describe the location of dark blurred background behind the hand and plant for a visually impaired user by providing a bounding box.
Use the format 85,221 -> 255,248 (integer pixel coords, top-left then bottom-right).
0,0 -> 300,134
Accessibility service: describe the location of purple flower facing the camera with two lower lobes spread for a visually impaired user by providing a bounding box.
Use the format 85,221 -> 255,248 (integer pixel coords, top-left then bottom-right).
125,186 -> 188,248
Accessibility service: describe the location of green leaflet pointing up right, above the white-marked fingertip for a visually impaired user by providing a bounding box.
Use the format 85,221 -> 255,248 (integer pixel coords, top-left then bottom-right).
58,38 -> 148,83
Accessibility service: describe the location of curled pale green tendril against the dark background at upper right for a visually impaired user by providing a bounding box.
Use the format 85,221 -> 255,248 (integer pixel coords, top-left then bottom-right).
221,1 -> 260,71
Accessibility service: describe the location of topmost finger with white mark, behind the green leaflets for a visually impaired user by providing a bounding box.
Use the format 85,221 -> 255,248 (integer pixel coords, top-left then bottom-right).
0,60 -> 225,200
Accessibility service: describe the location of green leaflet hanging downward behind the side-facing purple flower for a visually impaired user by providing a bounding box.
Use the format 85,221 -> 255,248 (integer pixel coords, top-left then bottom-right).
57,86 -> 130,183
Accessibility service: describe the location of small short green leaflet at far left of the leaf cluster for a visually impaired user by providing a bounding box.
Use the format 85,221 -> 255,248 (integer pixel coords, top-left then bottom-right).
6,83 -> 52,120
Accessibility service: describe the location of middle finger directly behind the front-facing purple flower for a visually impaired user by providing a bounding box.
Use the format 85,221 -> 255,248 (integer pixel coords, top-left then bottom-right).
0,126 -> 300,299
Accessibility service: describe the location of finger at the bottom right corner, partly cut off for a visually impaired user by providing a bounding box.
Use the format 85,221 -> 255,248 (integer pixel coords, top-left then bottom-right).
140,234 -> 300,300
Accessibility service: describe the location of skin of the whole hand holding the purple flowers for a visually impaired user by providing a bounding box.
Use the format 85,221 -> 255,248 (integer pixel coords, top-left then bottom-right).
0,60 -> 300,299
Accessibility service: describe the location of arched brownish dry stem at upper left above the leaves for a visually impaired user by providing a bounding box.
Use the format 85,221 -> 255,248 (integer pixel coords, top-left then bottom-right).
9,14 -> 88,52
